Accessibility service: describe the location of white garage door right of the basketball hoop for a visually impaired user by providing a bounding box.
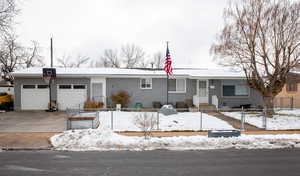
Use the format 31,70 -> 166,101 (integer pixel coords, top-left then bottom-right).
57,84 -> 87,110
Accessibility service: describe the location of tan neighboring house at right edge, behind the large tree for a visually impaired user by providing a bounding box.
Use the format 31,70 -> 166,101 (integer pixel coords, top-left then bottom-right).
275,71 -> 300,108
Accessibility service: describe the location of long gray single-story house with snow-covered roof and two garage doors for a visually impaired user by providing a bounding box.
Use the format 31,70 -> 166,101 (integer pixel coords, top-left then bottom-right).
12,68 -> 262,110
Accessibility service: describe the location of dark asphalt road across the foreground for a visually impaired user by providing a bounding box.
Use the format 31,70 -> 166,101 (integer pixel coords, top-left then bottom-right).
0,149 -> 300,176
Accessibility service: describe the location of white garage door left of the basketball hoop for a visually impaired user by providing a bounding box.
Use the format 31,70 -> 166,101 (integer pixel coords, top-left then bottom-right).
21,84 -> 49,110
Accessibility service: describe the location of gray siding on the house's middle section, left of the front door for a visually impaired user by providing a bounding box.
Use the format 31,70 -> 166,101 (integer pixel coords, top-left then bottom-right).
106,78 -> 196,107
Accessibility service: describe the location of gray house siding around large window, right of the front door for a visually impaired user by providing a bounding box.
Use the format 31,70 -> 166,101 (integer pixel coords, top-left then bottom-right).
209,80 -> 263,107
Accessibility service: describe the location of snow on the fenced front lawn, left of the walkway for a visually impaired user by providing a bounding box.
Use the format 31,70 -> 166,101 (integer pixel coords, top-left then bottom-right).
77,111 -> 234,131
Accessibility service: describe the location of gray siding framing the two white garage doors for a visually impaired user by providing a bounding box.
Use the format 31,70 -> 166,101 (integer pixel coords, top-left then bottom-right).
14,77 -> 90,110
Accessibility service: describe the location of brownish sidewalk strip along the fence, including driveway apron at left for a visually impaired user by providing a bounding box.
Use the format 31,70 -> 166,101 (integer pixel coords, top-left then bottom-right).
0,130 -> 300,150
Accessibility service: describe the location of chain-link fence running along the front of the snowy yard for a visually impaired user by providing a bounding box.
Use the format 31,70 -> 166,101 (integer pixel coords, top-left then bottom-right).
67,108 -> 300,132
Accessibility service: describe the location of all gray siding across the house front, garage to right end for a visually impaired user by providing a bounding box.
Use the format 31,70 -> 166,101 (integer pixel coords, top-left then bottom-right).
14,77 -> 263,110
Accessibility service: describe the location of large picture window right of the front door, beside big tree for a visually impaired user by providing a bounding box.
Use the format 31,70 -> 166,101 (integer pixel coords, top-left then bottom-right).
223,80 -> 249,96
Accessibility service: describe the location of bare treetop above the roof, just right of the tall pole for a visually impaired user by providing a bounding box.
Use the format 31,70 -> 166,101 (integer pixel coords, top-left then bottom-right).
57,54 -> 90,68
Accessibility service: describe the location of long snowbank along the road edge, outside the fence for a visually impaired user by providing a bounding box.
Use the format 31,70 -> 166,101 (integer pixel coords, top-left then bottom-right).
51,127 -> 300,151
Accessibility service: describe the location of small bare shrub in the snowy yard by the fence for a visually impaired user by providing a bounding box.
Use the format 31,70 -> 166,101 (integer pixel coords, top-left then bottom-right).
133,112 -> 157,139
